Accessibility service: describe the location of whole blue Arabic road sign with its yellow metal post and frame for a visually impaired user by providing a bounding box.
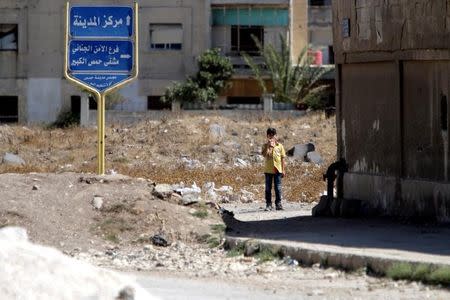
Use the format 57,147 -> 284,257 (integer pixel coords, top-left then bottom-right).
64,2 -> 139,175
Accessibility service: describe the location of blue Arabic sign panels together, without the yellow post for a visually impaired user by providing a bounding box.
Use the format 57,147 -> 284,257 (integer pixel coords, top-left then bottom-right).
67,6 -> 135,92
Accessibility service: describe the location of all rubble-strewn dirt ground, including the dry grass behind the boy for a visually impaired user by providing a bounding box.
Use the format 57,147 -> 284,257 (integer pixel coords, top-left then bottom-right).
0,113 -> 447,299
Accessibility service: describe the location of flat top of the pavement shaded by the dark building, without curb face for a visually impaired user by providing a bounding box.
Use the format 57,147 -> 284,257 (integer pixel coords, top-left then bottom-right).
221,203 -> 450,266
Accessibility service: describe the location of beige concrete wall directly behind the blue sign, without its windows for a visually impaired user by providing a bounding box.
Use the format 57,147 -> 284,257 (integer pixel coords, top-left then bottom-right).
0,0 -> 210,123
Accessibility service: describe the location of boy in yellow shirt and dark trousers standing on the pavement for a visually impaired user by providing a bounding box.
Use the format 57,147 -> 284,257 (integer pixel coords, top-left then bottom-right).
262,128 -> 286,211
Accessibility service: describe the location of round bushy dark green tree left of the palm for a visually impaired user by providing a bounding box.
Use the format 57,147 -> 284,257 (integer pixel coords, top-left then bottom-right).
162,49 -> 233,103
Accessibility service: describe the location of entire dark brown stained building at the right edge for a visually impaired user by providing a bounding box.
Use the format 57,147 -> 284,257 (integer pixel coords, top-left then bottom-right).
333,0 -> 450,221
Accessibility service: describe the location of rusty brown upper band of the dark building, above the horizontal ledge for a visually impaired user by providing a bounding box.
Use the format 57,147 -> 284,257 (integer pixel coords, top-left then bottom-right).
332,0 -> 450,62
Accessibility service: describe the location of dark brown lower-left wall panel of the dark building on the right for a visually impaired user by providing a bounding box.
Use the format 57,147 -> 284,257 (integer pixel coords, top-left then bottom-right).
339,62 -> 401,176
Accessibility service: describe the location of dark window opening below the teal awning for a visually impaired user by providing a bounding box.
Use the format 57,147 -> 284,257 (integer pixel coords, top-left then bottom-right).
231,25 -> 264,55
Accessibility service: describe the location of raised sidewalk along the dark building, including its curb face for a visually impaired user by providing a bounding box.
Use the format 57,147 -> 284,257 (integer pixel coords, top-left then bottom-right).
223,203 -> 450,273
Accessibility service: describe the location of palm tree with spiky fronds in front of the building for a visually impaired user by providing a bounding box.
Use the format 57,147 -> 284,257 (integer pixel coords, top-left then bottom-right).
242,35 -> 329,108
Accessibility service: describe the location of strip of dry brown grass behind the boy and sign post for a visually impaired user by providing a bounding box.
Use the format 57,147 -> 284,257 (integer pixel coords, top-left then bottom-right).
0,113 -> 336,201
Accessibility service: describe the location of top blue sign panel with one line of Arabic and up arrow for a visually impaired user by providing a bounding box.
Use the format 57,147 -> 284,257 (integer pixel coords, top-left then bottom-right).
69,6 -> 133,38
